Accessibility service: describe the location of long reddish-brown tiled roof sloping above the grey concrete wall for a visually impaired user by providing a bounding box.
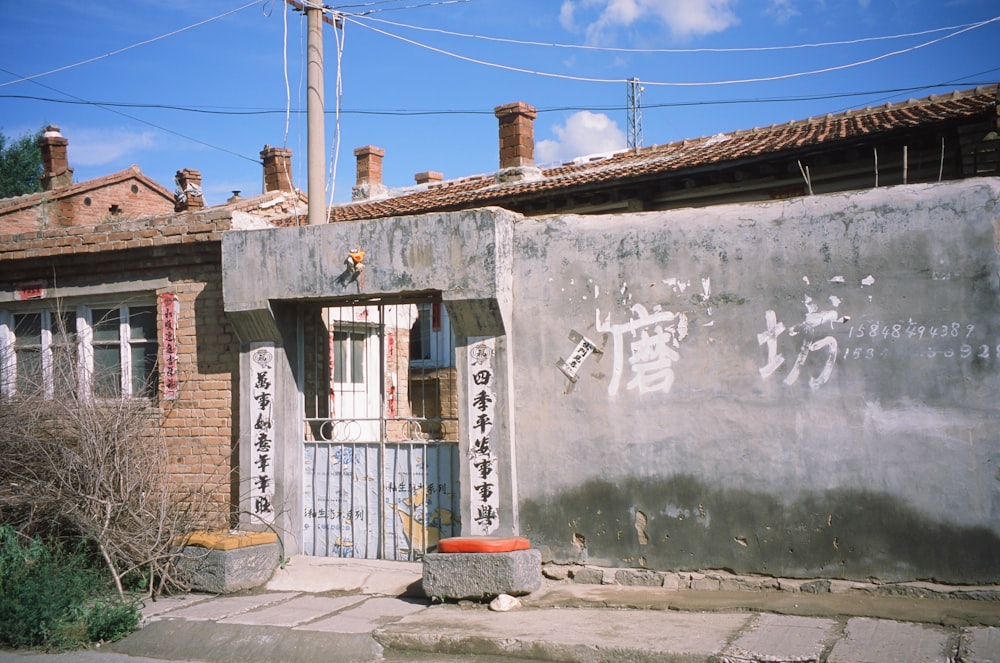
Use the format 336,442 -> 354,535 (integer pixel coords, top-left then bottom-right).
331,85 -> 998,221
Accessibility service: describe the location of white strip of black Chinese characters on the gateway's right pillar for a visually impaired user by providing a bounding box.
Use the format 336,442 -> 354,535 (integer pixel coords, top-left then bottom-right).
468,338 -> 500,535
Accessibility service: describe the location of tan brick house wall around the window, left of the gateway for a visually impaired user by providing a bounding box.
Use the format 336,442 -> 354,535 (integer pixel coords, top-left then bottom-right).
0,211 -> 239,528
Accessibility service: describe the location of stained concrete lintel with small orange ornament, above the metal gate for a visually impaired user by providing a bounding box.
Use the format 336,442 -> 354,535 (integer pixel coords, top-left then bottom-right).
222,208 -> 519,322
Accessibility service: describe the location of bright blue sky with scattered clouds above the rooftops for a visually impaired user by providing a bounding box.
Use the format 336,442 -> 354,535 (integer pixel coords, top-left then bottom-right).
0,0 -> 1000,204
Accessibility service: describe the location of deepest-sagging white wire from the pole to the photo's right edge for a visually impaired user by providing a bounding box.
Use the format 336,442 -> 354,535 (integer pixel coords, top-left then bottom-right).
344,15 -> 1000,87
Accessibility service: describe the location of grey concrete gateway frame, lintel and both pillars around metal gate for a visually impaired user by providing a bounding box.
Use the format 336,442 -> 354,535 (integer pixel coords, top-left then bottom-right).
222,208 -> 520,555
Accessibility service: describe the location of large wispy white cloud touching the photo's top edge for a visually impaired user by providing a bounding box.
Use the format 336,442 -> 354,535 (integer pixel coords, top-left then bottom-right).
560,0 -> 739,43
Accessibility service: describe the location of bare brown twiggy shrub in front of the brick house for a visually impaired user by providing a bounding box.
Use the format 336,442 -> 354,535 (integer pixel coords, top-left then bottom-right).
0,322 -> 224,596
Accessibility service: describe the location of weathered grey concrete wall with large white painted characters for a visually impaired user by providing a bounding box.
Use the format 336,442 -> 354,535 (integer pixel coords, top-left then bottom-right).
512,179 -> 1000,583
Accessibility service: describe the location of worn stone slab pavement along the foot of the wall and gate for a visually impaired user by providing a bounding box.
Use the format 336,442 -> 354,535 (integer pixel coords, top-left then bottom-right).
0,558 -> 1000,663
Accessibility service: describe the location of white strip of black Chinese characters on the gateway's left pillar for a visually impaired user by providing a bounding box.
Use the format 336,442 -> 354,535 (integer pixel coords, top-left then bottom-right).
250,343 -> 275,516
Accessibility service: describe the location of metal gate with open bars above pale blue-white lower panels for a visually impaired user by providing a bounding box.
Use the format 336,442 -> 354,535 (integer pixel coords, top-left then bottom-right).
300,297 -> 461,560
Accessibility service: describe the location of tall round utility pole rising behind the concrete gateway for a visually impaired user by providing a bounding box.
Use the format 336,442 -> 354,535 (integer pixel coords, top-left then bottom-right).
305,0 -> 326,226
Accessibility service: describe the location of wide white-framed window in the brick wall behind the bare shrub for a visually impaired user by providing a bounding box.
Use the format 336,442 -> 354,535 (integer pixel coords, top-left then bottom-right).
0,304 -> 159,398
